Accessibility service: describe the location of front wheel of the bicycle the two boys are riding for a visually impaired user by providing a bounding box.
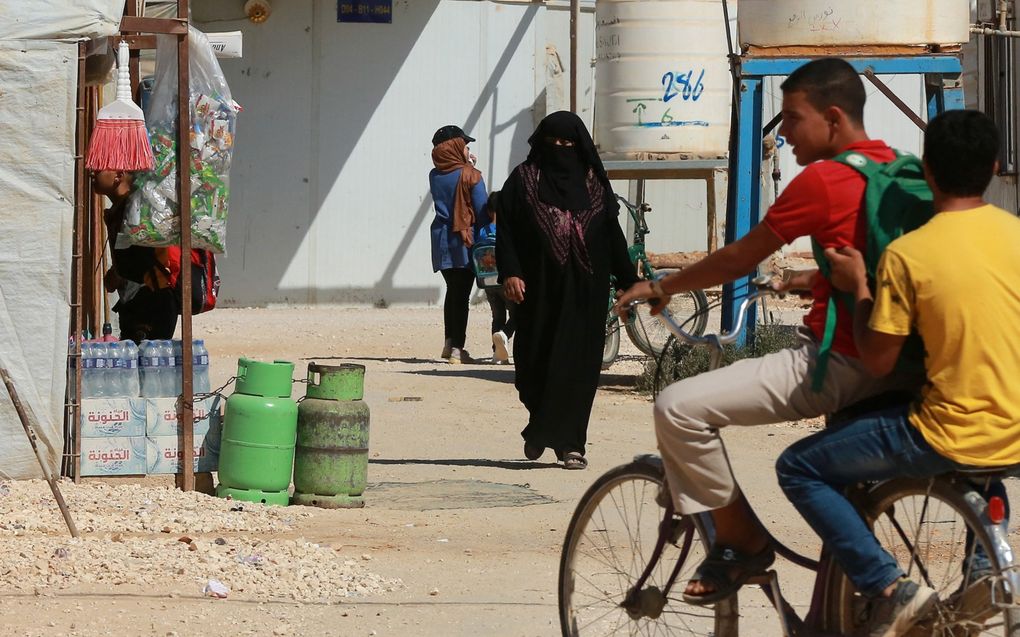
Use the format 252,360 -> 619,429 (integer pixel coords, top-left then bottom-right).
559,461 -> 716,637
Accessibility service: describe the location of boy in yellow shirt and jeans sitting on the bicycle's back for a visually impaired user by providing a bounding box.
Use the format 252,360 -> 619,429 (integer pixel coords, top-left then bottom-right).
776,111 -> 1020,637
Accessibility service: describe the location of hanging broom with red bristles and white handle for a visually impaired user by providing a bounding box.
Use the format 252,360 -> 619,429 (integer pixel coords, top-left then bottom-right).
85,40 -> 154,171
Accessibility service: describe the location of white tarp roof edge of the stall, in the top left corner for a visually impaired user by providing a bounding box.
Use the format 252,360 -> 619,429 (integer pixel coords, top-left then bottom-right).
0,0 -> 124,40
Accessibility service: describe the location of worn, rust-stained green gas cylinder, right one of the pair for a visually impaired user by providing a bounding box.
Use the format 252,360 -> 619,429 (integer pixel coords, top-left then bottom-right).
292,363 -> 369,509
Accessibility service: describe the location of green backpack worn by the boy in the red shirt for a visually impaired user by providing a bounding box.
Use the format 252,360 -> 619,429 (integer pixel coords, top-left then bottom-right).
811,151 -> 934,391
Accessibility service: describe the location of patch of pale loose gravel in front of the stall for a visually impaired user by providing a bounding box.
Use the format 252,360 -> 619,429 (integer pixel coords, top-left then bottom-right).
0,480 -> 401,602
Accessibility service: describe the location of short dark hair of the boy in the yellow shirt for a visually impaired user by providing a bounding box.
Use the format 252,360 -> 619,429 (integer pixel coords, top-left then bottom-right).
924,110 -> 999,197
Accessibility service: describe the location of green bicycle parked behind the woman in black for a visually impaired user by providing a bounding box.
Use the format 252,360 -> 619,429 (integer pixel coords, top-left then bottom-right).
602,195 -> 708,369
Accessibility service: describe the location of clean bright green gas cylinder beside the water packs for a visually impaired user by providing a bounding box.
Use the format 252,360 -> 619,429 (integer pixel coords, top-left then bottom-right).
216,359 -> 298,506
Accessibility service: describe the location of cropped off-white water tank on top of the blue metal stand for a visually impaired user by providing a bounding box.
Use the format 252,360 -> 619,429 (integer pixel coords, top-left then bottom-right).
737,0 -> 970,47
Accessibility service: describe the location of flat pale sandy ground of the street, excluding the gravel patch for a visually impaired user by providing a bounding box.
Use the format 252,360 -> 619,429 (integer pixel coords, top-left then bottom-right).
0,305 -> 1011,636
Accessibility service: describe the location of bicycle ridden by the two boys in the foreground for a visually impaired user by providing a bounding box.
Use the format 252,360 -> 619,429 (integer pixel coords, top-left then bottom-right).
558,279 -> 1020,637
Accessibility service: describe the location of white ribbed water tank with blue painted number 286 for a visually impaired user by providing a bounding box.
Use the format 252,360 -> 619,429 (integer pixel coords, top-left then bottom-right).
595,0 -> 744,159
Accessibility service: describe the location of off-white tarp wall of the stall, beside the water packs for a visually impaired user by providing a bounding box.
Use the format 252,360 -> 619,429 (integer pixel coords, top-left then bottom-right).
0,39 -> 75,478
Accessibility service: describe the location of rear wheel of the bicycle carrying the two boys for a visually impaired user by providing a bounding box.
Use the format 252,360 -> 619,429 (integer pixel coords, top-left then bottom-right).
826,479 -> 1020,637
